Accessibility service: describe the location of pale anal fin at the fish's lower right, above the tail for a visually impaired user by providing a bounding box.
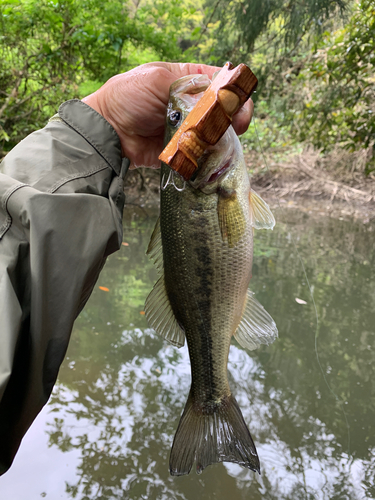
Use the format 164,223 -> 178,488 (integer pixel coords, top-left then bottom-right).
234,290 -> 278,351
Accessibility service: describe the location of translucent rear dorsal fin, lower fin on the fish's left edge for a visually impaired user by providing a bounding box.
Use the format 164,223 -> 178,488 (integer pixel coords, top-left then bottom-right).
145,274 -> 185,347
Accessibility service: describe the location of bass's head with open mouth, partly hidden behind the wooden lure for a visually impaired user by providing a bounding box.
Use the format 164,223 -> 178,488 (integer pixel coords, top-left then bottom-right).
165,75 -> 243,194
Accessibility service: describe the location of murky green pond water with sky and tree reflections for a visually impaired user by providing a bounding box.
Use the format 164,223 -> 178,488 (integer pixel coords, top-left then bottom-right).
0,204 -> 375,500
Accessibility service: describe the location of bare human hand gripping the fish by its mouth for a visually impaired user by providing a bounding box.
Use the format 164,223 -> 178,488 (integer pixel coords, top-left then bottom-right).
82,62 -> 254,168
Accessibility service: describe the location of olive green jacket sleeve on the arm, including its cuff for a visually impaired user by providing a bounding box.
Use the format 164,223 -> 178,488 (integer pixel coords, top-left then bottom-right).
0,100 -> 129,474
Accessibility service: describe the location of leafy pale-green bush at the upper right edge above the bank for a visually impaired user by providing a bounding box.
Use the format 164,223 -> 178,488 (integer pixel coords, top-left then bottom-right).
296,0 -> 375,149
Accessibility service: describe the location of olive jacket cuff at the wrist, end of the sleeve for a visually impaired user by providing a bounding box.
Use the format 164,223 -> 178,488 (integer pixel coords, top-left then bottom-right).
59,99 -> 122,175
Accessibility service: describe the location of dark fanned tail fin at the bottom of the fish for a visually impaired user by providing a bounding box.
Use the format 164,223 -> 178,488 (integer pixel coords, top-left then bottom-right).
169,395 -> 260,476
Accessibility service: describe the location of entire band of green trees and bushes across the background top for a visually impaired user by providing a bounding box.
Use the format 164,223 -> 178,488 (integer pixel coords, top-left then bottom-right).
0,0 -> 375,172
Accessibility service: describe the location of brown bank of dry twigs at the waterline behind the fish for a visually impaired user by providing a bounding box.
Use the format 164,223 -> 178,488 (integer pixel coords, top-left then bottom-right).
124,162 -> 375,224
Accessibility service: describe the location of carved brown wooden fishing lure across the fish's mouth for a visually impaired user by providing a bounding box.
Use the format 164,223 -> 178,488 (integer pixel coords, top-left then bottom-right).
159,62 -> 258,181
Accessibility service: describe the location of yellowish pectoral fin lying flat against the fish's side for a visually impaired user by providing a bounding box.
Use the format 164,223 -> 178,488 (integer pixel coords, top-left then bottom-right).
217,190 -> 246,248
